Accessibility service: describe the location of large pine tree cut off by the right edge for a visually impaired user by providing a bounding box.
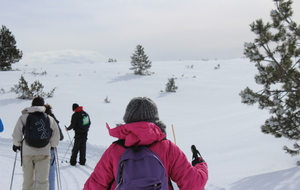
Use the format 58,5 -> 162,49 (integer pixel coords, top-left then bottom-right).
240,0 -> 300,155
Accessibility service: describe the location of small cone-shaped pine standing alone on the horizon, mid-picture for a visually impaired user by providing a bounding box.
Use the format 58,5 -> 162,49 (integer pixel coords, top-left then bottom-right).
130,45 -> 152,75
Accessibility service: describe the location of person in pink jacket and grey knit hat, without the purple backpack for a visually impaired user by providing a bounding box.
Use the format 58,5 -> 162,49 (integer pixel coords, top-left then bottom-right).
83,97 -> 208,190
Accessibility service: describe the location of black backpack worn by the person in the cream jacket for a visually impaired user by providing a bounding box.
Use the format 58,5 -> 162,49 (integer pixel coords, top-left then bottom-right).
23,113 -> 52,148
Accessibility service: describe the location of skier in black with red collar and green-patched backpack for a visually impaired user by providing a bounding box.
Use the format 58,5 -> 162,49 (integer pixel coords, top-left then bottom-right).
66,103 -> 91,166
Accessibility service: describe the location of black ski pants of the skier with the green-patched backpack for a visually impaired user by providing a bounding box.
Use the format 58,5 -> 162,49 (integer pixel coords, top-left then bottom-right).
70,133 -> 87,166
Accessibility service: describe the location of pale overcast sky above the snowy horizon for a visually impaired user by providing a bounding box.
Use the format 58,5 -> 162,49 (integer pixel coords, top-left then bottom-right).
0,0 -> 300,61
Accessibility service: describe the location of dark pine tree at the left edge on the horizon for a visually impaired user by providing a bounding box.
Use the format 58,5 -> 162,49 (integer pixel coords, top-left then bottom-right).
0,25 -> 23,71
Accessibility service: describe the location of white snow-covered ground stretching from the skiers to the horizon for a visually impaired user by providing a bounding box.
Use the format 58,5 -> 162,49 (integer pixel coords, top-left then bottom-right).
0,52 -> 300,190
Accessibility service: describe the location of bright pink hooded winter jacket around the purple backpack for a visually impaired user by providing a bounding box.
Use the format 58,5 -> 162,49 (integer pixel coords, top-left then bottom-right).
83,122 -> 208,190
